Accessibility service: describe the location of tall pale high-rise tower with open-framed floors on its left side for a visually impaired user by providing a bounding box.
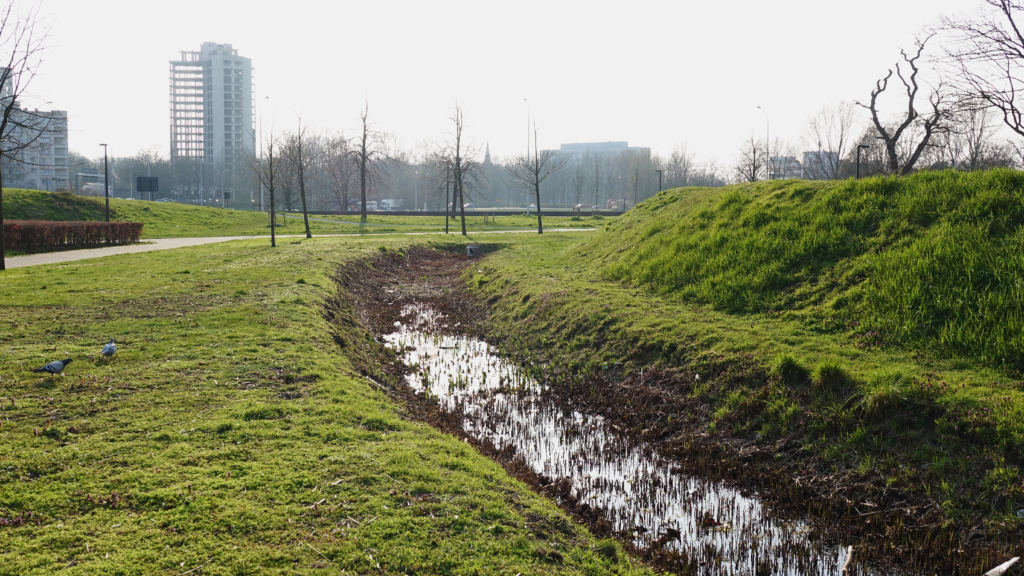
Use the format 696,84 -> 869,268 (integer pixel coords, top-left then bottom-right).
170,42 -> 256,169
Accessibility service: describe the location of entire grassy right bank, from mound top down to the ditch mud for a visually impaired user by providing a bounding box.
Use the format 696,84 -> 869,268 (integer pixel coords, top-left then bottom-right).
470,170 -> 1024,532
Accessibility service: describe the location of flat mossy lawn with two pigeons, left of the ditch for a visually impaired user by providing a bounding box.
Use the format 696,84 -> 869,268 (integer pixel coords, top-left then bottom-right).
0,238 -> 647,575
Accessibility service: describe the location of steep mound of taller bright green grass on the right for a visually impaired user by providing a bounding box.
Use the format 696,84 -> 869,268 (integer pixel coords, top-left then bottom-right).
598,170 -> 1024,371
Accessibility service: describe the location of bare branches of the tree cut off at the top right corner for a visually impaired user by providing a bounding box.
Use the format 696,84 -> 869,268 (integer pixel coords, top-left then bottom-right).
942,0 -> 1024,136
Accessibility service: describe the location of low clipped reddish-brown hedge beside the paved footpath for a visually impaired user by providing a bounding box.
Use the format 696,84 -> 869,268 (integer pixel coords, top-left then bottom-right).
3,220 -> 142,252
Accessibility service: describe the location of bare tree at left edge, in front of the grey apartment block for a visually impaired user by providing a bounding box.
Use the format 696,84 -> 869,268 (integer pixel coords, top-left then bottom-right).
0,0 -> 50,271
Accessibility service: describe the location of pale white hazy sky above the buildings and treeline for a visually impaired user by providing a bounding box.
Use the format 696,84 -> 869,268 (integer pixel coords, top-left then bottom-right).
26,0 -> 980,163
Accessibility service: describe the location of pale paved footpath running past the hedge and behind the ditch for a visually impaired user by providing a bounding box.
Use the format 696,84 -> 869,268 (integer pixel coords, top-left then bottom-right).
5,228 -> 596,269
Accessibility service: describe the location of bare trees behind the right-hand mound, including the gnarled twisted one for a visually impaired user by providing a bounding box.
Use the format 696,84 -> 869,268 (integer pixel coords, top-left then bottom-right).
734,0 -> 1024,181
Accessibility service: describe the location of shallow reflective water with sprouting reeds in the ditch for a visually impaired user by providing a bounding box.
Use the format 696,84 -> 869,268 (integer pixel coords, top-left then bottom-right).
385,306 -> 860,576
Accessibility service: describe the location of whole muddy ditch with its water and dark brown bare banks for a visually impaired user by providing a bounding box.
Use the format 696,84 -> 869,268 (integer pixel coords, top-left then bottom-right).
326,248 -> 1020,576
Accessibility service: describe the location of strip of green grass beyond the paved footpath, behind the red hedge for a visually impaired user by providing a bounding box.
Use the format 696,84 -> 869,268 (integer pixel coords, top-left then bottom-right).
3,190 -> 607,239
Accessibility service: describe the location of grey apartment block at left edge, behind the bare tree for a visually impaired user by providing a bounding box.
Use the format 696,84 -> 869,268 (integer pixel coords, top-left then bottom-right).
0,69 -> 71,192
